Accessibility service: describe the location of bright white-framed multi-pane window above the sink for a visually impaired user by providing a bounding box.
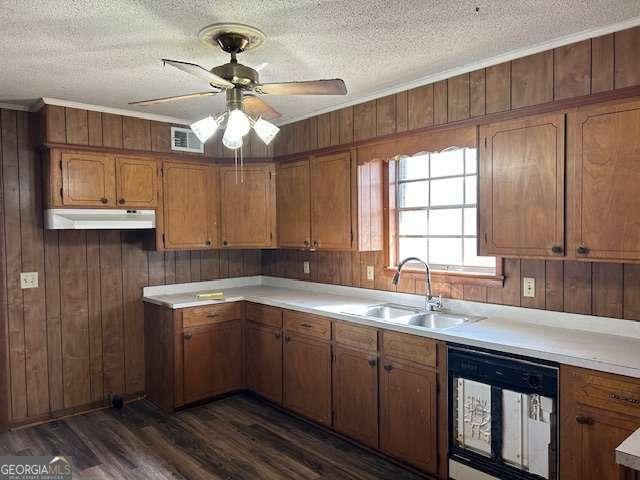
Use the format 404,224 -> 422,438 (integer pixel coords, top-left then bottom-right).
393,147 -> 496,275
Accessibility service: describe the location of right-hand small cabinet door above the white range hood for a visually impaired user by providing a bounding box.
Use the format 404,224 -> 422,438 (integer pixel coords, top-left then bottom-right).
116,157 -> 158,208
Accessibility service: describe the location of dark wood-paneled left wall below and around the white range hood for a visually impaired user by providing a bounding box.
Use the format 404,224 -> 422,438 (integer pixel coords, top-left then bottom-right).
0,109 -> 261,426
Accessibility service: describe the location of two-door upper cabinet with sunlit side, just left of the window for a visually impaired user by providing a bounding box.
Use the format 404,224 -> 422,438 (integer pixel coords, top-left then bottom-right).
277,151 -> 383,251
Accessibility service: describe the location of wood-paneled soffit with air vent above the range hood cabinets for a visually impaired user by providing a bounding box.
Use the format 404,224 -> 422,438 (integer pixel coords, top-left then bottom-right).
43,105 -> 273,159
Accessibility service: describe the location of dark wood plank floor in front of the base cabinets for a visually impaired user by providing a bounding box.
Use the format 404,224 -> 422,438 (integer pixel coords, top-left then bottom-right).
0,395 -> 430,480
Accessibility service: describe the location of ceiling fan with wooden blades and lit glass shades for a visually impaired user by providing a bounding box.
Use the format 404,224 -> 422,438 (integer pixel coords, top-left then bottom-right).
129,23 -> 347,150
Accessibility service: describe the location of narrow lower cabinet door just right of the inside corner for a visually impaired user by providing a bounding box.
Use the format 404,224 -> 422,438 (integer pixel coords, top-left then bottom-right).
246,324 -> 282,404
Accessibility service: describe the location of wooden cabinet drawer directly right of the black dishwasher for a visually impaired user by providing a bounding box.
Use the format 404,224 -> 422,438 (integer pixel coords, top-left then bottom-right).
567,368 -> 640,417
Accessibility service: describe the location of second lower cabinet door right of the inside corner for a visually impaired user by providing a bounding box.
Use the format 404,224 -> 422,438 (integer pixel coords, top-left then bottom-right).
284,334 -> 331,425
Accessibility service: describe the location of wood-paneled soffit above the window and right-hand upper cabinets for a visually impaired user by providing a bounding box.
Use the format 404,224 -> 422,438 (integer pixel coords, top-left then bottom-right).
274,27 -> 640,157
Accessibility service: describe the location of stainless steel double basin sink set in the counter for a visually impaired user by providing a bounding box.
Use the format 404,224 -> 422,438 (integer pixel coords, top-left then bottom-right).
342,303 -> 484,330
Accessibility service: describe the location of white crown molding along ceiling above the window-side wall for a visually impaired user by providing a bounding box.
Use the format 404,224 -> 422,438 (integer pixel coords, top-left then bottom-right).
277,17 -> 640,126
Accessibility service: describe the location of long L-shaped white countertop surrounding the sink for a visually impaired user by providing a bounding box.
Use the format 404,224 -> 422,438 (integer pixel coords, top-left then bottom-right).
143,276 -> 640,378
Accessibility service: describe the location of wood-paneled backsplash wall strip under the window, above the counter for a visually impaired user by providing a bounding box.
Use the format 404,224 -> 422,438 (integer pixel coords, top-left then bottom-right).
262,250 -> 640,320
